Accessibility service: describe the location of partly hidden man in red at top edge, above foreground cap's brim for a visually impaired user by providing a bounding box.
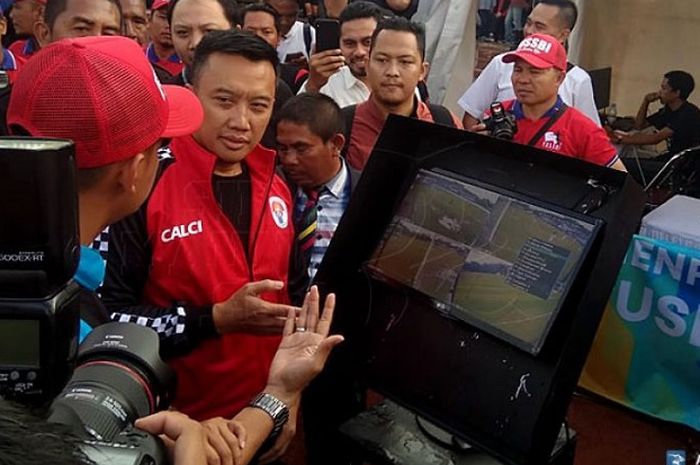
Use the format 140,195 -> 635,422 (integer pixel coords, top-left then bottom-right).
146,0 -> 185,80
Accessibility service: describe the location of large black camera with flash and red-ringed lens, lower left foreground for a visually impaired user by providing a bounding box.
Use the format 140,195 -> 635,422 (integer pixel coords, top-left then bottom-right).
0,138 -> 175,465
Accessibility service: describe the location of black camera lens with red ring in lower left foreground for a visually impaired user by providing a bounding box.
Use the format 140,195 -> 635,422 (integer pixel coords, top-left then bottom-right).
48,322 -> 175,465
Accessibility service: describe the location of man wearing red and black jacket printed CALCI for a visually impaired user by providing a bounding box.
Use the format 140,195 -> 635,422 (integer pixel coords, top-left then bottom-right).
102,30 -> 306,454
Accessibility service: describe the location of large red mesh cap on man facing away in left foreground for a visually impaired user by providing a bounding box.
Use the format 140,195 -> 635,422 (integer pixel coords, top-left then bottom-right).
7,36 -> 204,168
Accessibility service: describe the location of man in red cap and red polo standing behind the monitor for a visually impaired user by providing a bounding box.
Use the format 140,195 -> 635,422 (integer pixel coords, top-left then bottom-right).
502,34 -> 625,171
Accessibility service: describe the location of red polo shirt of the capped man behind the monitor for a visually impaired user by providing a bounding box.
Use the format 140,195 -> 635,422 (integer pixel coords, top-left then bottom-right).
503,98 -> 617,166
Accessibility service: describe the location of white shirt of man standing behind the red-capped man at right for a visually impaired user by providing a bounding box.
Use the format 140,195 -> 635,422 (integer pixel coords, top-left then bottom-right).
457,53 -> 600,126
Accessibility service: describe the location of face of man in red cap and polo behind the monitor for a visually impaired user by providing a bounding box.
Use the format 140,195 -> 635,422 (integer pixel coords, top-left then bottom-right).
511,59 -> 564,105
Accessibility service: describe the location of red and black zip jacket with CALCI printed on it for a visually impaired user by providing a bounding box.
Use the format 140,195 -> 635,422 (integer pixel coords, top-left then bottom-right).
103,137 -> 294,420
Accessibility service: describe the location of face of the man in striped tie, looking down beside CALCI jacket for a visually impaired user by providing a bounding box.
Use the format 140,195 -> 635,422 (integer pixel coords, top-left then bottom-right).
277,121 -> 342,189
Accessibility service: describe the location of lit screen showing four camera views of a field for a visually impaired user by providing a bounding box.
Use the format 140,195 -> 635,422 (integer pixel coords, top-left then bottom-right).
367,170 -> 599,354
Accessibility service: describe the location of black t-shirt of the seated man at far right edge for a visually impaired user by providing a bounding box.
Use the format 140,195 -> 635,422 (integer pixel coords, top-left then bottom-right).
647,102 -> 700,154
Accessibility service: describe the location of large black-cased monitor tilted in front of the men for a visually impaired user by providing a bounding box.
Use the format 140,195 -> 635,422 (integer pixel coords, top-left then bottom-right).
314,116 -> 645,465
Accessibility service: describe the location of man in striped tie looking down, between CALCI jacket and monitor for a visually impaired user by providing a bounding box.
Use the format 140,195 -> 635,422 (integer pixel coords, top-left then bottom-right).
277,94 -> 360,280
